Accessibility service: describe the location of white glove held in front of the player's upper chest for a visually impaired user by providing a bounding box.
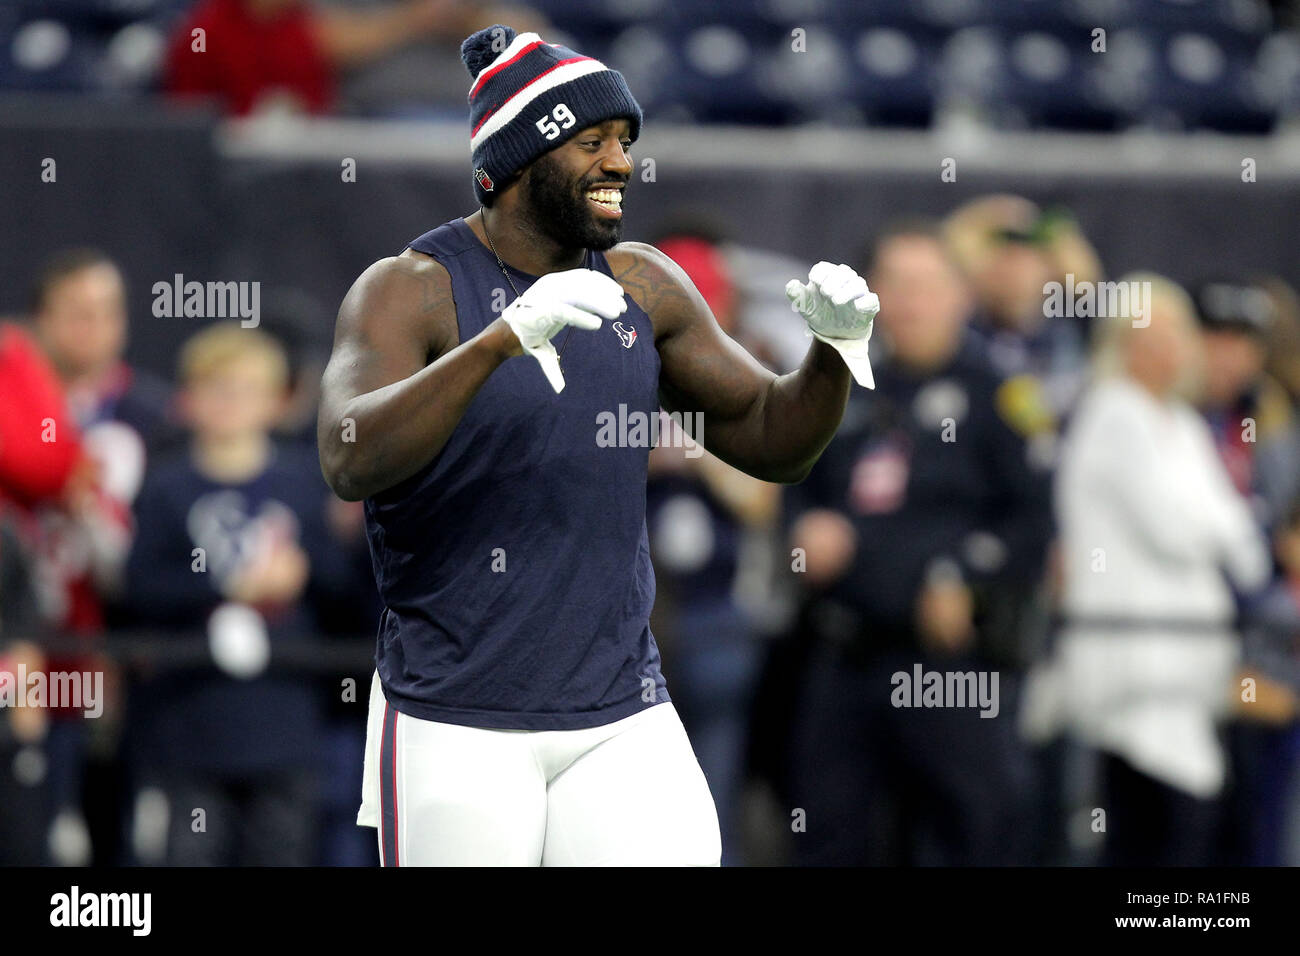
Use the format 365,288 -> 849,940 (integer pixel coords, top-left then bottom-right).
501,269 -> 628,392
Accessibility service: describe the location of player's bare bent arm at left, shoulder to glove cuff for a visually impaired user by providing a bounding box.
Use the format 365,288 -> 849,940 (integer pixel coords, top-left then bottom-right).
317,250 -> 521,501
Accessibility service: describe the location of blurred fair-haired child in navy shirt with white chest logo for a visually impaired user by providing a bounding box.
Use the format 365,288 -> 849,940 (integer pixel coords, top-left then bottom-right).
120,323 -> 339,865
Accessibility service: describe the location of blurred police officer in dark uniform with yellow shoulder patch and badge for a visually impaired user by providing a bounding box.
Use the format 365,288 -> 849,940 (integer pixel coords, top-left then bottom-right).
788,224 -> 1053,865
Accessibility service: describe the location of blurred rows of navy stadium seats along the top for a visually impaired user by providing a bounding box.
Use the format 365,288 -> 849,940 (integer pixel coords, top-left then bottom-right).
0,0 -> 1300,133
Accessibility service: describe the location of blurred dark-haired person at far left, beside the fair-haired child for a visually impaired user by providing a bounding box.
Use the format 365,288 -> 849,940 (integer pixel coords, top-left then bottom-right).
31,248 -> 173,864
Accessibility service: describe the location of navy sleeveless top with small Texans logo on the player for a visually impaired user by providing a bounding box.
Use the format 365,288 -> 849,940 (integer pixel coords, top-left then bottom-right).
365,219 -> 670,730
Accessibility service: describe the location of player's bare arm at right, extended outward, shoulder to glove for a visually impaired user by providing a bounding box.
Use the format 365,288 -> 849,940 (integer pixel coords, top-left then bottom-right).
608,242 -> 852,483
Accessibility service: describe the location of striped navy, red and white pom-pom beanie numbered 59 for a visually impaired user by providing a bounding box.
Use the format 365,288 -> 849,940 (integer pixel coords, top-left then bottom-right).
460,23 -> 641,206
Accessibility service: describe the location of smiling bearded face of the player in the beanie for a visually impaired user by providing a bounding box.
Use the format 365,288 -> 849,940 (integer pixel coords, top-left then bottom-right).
524,120 -> 632,250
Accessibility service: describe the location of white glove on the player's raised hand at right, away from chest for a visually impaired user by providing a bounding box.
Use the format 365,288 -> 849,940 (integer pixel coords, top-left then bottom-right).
785,261 -> 880,389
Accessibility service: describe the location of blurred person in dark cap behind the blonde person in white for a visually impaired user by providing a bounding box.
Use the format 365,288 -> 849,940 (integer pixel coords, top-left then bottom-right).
1196,282 -> 1300,527
